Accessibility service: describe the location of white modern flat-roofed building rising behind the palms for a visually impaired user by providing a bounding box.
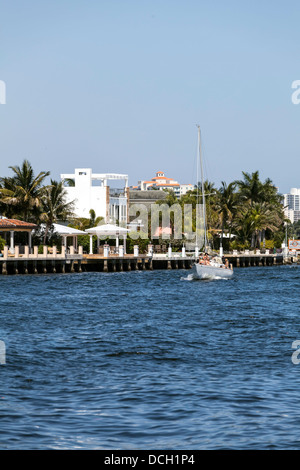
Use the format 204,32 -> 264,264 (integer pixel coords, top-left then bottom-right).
60,168 -> 129,223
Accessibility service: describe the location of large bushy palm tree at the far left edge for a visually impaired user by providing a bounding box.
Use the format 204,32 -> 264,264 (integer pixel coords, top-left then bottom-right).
0,160 -> 50,221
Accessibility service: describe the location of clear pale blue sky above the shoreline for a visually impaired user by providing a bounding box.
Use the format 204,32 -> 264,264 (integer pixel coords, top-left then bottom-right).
0,0 -> 300,192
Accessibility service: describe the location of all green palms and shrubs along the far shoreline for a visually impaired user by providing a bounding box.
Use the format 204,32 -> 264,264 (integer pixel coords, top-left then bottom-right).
0,160 -> 292,252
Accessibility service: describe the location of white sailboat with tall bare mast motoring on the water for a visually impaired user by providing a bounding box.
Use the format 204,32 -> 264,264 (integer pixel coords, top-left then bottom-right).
192,126 -> 233,279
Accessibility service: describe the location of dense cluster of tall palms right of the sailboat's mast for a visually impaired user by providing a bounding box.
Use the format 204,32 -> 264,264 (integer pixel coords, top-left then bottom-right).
158,171 -> 286,250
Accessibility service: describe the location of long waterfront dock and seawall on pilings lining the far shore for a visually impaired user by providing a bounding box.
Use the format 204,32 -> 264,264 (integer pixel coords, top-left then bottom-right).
0,246 -> 298,275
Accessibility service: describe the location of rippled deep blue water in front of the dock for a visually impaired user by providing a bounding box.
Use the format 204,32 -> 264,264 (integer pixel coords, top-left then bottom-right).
0,266 -> 300,450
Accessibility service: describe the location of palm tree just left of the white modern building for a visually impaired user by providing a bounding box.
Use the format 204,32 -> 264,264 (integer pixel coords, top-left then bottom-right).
40,179 -> 74,244
